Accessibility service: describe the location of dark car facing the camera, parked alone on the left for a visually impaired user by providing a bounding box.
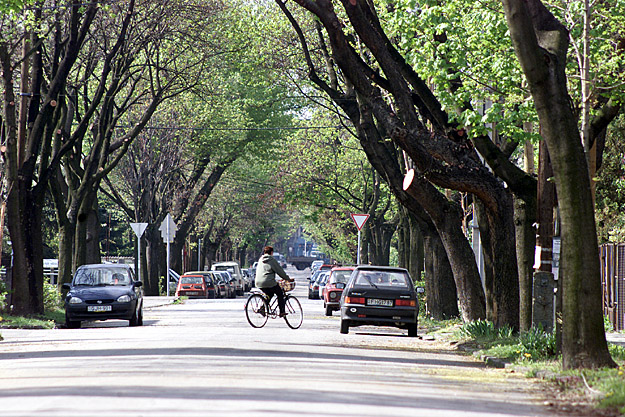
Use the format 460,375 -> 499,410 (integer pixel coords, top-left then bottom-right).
63,264 -> 143,329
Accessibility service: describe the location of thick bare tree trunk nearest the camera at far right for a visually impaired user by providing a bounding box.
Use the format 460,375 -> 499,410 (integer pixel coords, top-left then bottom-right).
503,0 -> 616,369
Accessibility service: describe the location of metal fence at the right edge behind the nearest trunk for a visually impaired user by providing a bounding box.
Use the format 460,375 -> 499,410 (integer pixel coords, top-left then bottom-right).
599,243 -> 625,331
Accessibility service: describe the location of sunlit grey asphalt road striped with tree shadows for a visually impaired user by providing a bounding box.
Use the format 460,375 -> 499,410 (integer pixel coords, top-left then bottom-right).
0,269 -> 553,417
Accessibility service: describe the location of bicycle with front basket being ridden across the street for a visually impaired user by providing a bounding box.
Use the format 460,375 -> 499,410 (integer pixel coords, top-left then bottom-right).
245,281 -> 304,329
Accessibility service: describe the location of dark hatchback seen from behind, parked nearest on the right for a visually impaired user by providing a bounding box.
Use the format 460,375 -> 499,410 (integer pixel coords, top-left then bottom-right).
341,265 -> 419,337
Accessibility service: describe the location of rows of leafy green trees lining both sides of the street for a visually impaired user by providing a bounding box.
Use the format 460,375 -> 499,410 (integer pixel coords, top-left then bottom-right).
0,0 -> 625,368
